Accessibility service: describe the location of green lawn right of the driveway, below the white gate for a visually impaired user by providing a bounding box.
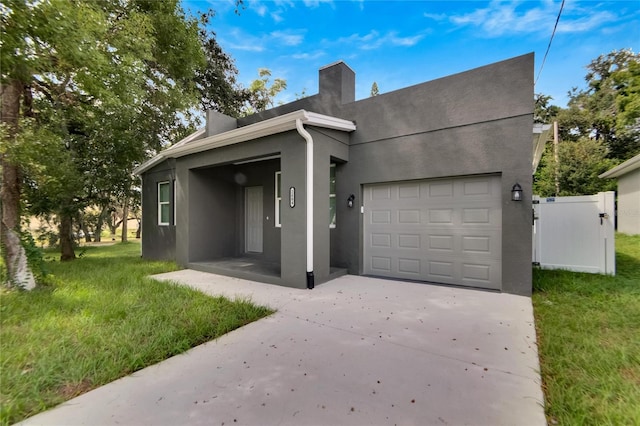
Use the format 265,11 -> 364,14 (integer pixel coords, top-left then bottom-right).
533,234 -> 640,425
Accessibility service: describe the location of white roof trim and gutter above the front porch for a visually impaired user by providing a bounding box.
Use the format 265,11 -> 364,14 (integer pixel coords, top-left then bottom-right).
133,109 -> 356,175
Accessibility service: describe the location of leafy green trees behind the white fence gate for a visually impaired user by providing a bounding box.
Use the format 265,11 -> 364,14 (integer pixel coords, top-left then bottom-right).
534,49 -> 640,196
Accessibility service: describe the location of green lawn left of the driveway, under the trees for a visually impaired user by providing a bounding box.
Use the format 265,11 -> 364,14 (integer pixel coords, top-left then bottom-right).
0,243 -> 272,425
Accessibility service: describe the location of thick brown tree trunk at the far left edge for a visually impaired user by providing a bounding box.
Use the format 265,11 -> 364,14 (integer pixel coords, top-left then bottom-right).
0,80 -> 36,290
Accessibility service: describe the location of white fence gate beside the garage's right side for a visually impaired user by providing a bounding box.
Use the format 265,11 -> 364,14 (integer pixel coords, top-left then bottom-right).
533,191 -> 616,275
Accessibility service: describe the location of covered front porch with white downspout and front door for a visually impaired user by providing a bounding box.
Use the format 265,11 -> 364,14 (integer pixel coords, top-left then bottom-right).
176,112 -> 352,288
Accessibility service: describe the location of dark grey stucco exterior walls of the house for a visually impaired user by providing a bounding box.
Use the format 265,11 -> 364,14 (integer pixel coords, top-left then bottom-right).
143,54 -> 534,295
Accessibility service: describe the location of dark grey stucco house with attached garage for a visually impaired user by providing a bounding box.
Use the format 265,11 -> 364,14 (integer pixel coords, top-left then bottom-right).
136,54 -> 534,295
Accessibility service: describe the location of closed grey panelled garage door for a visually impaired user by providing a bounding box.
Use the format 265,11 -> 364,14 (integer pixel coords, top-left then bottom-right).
364,176 -> 502,289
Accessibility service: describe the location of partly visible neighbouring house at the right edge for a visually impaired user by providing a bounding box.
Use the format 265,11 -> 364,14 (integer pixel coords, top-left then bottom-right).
600,154 -> 640,235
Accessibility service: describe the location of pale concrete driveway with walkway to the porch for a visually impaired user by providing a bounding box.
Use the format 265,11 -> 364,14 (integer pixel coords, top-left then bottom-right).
22,270 -> 545,426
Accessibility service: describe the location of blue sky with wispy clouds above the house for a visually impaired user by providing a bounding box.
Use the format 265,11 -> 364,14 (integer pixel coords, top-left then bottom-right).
183,0 -> 640,106
